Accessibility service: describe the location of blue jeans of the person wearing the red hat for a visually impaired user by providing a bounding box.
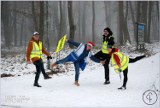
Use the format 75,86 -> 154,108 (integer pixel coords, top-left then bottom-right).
56,56 -> 80,80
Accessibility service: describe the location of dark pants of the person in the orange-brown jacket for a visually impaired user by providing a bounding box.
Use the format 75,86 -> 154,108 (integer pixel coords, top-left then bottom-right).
34,60 -> 47,83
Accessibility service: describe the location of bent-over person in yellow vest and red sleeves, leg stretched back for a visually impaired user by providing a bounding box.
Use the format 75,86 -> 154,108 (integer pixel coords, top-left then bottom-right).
107,48 -> 146,90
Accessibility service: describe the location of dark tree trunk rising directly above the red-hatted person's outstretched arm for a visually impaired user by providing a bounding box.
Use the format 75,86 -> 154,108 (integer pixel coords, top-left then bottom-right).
68,1 -> 75,48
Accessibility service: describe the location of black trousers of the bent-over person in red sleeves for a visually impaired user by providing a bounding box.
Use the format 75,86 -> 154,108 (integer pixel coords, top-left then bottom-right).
122,55 -> 145,87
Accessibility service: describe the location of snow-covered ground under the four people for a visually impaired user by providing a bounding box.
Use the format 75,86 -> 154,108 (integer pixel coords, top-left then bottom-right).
0,42 -> 160,108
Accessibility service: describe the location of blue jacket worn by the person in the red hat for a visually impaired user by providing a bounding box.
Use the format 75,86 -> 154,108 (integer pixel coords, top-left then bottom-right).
67,40 -> 100,71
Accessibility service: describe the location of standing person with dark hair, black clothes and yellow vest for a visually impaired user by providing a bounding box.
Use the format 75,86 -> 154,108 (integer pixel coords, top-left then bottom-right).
94,27 -> 114,84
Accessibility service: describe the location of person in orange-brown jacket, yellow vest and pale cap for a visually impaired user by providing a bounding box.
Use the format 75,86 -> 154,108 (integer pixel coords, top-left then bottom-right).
26,32 -> 52,87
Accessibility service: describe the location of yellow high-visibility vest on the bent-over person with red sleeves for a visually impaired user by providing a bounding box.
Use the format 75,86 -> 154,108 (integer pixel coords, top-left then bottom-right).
111,52 -> 129,73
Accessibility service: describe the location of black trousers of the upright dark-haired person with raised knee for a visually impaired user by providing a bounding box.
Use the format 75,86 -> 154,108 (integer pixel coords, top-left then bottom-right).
94,51 -> 111,81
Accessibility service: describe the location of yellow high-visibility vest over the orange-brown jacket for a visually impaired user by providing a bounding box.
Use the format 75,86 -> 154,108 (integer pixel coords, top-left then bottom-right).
30,41 -> 42,59
